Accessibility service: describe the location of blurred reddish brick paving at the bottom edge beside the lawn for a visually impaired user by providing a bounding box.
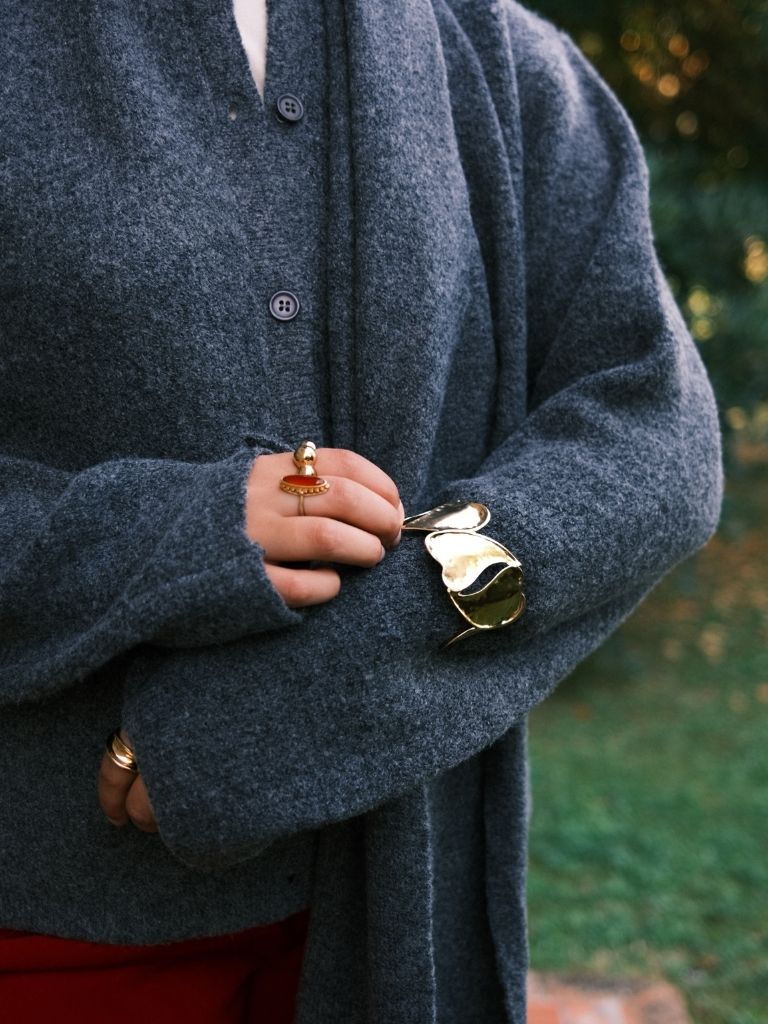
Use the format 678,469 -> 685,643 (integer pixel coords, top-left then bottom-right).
528,972 -> 691,1024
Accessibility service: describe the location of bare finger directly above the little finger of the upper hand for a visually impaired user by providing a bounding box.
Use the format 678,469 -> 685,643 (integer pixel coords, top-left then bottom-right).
264,515 -> 385,571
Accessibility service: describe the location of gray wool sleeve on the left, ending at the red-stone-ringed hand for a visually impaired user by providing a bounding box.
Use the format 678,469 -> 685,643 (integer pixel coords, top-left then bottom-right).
0,449 -> 300,702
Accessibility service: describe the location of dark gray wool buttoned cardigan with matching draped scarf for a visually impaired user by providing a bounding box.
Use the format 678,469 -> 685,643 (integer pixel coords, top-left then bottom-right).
0,0 -> 722,1024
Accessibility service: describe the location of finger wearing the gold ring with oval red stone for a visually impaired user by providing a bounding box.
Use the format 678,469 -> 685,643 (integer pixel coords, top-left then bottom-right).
279,476 -> 402,548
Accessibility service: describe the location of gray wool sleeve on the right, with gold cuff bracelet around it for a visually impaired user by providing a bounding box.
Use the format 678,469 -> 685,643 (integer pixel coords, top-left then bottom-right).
118,15 -> 722,867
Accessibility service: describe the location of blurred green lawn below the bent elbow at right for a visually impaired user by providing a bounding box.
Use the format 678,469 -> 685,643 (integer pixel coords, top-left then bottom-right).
528,470 -> 768,1024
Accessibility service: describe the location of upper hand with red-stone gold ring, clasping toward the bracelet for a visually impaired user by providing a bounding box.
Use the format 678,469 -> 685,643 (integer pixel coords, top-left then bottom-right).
246,449 -> 403,608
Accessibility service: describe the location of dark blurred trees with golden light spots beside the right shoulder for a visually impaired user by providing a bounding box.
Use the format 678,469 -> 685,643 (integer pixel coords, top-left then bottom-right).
534,0 -> 768,461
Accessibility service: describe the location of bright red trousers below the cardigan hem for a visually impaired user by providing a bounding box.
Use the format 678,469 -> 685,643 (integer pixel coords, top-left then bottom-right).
0,910 -> 309,1024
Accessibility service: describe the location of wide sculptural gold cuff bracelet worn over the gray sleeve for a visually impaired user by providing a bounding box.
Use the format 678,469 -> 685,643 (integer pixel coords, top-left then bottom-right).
402,502 -> 525,647
